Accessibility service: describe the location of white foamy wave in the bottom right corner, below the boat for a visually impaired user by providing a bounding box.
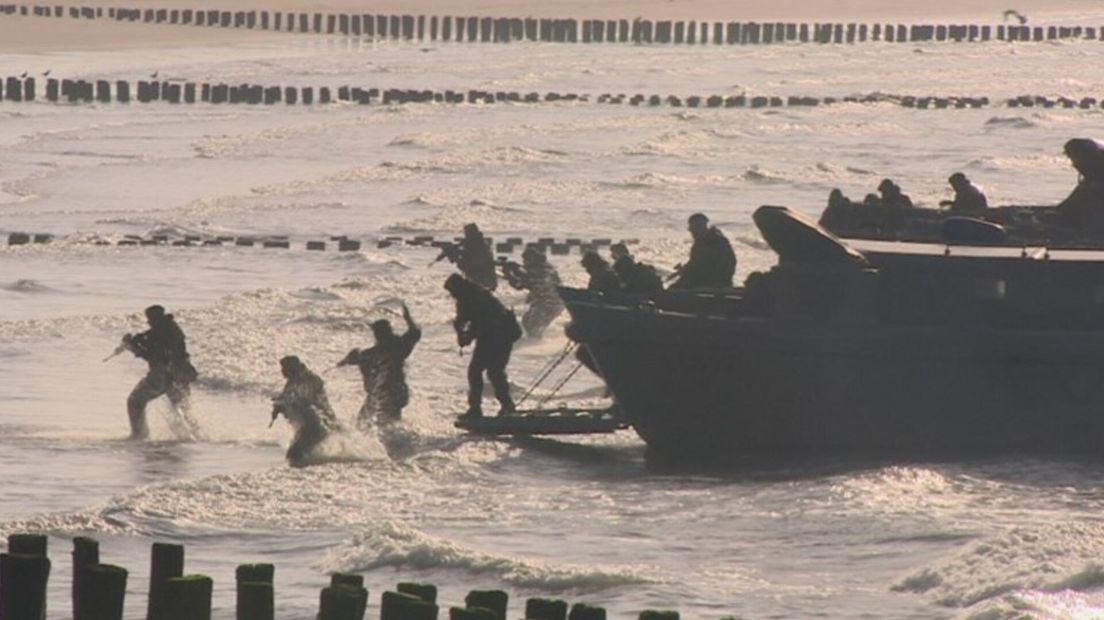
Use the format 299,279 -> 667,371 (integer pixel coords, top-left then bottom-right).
891,523 -> 1104,607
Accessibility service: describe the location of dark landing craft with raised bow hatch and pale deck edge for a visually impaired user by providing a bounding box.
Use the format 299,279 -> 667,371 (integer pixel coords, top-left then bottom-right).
561,206 -> 1104,460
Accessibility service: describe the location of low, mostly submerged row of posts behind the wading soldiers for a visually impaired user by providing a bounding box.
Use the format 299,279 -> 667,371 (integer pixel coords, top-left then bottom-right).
0,233 -> 639,255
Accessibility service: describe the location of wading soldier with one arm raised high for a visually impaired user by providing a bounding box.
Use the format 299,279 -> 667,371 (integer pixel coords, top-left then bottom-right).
338,303 -> 422,427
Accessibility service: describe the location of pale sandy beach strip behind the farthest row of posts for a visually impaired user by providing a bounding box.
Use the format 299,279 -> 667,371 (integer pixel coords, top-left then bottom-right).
0,0 -> 1104,53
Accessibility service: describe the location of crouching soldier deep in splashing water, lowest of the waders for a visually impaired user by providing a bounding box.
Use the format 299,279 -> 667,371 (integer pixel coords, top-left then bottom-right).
269,355 -> 337,467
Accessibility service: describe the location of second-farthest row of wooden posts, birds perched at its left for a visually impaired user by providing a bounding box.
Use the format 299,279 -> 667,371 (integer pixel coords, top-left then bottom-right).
0,77 -> 1104,109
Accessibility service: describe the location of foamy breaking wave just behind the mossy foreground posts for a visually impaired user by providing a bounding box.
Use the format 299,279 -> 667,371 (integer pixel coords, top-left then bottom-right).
316,522 -> 656,591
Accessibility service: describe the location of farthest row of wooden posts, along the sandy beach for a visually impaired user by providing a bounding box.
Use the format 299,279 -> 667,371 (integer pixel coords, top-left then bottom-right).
0,4 -> 1104,45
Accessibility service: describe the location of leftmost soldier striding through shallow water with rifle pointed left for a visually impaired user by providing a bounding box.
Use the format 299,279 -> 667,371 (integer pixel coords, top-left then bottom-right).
123,306 -> 198,439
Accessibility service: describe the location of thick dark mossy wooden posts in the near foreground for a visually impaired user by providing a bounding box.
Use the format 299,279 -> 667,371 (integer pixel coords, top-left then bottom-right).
0,534 -> 710,620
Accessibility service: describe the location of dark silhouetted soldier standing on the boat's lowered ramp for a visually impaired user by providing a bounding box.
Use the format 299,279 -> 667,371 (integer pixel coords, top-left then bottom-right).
445,274 -> 521,418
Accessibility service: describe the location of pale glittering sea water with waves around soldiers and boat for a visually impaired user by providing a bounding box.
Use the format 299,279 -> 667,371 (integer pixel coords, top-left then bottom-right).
0,15 -> 1104,619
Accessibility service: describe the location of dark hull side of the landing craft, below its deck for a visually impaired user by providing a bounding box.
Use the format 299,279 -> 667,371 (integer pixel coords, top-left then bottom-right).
569,302 -> 1104,460
